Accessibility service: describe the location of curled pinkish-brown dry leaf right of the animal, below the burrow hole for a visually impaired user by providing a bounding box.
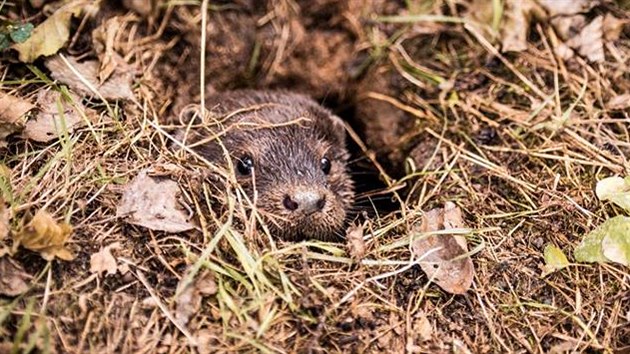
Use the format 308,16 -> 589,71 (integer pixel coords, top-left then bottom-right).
412,203 -> 474,294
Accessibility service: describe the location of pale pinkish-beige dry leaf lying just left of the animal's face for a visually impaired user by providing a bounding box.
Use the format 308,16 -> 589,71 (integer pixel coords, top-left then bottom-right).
116,169 -> 194,232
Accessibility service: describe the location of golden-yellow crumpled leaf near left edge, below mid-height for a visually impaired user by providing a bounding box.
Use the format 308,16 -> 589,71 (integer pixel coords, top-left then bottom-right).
15,210 -> 74,261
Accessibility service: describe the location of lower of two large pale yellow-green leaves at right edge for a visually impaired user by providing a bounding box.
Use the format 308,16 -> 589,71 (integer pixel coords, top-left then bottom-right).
573,215 -> 630,265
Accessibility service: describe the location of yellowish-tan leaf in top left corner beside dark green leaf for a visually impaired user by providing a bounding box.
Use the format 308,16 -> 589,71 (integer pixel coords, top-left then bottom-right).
12,6 -> 81,63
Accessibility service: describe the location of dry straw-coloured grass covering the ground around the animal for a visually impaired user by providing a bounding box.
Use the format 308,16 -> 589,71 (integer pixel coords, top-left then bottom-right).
0,2 -> 630,353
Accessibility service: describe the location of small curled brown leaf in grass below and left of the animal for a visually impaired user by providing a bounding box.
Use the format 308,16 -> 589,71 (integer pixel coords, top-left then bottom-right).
175,271 -> 217,325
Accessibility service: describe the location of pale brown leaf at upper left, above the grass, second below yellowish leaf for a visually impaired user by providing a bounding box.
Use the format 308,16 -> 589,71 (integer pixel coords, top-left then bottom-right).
22,90 -> 96,143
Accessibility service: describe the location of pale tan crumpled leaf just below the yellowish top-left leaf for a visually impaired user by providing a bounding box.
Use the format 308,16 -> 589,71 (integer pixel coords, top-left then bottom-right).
45,54 -> 134,100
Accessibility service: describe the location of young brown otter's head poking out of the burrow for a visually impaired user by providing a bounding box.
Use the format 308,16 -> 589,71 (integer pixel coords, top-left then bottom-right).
178,90 -> 354,240
